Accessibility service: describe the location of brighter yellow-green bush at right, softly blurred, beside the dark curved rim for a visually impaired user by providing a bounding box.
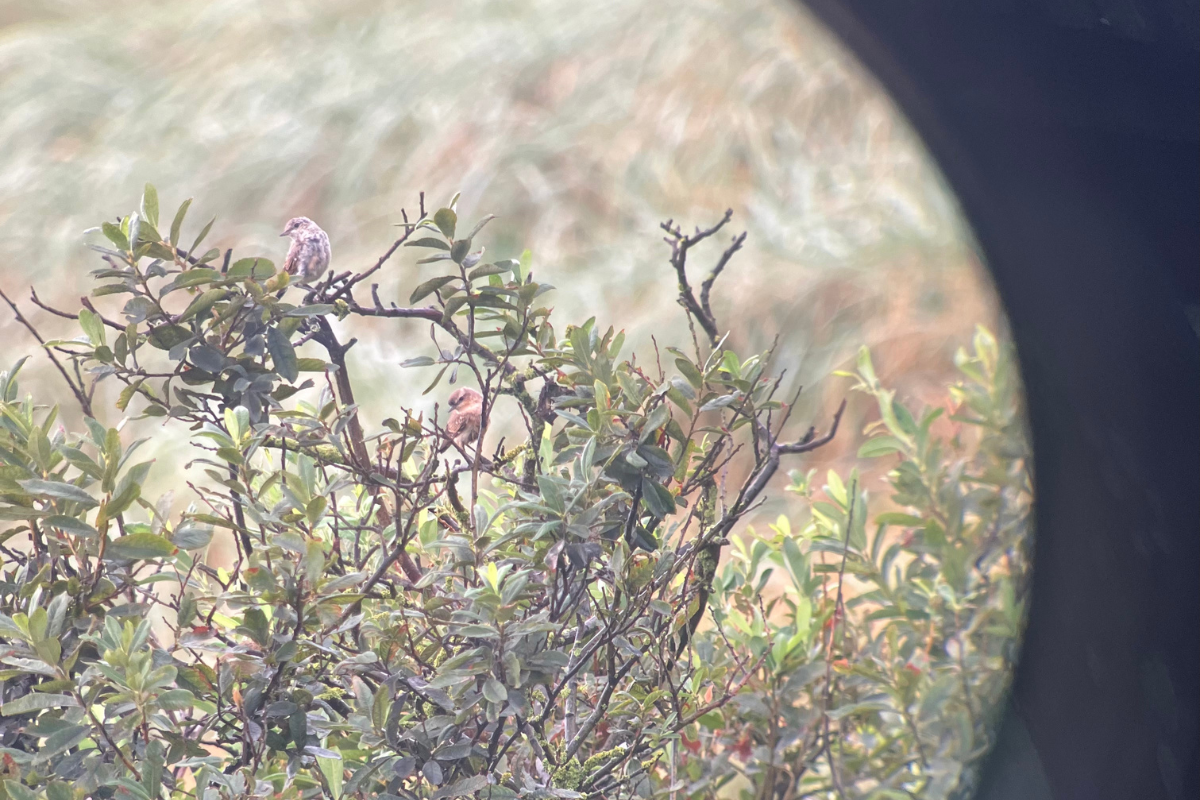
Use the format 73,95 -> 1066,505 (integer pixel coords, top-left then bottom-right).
679,329 -> 1031,800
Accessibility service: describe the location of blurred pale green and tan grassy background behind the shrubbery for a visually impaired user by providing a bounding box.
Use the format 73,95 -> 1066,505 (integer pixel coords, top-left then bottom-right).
0,0 -> 1003,518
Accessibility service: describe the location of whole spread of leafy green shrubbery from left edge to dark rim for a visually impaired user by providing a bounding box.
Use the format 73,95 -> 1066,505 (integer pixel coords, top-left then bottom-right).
0,186 -> 1028,800
